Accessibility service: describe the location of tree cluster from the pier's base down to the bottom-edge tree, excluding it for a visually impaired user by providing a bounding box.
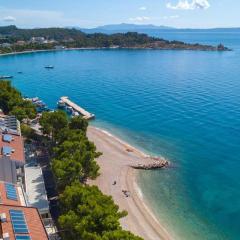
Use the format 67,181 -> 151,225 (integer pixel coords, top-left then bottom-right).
40,111 -> 101,191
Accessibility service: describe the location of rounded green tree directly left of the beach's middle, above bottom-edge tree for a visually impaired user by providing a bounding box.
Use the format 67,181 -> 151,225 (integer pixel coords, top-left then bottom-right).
52,135 -> 101,190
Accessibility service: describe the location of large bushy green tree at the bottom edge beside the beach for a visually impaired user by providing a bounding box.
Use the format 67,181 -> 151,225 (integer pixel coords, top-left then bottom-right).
59,183 -> 141,240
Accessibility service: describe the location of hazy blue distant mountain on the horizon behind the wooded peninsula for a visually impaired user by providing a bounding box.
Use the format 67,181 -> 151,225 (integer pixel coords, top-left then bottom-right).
73,23 -> 174,33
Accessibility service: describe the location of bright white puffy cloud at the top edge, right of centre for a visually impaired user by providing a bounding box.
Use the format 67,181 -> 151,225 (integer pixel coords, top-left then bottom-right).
166,0 -> 210,10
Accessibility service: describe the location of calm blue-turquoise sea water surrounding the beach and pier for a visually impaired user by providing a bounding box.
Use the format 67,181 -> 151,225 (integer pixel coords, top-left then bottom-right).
0,32 -> 240,240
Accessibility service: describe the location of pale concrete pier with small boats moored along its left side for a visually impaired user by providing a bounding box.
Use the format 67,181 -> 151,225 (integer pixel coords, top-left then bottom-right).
58,96 -> 95,120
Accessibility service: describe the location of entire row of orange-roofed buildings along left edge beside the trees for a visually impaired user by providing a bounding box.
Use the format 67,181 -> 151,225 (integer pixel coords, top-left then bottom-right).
0,112 -> 54,240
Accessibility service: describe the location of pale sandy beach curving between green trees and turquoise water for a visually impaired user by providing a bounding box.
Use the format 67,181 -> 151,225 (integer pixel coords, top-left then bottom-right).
87,126 -> 173,240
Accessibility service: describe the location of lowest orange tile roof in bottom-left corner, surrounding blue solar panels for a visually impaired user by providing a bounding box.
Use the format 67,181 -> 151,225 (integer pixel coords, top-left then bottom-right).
0,205 -> 48,240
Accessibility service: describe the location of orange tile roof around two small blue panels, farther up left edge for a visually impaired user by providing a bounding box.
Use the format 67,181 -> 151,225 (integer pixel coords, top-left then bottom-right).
0,134 -> 25,163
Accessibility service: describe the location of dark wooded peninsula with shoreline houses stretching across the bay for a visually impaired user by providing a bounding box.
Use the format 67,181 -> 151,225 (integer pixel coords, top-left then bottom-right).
0,25 -> 230,54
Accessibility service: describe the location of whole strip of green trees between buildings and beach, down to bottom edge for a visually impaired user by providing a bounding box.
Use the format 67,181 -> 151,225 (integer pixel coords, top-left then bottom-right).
40,111 -> 141,240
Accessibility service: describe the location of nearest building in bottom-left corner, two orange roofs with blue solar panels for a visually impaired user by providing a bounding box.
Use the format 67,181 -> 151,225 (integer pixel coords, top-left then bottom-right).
0,182 -> 48,240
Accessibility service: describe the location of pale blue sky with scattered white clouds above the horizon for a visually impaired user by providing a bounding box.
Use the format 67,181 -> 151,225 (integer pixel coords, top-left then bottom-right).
0,0 -> 240,28
